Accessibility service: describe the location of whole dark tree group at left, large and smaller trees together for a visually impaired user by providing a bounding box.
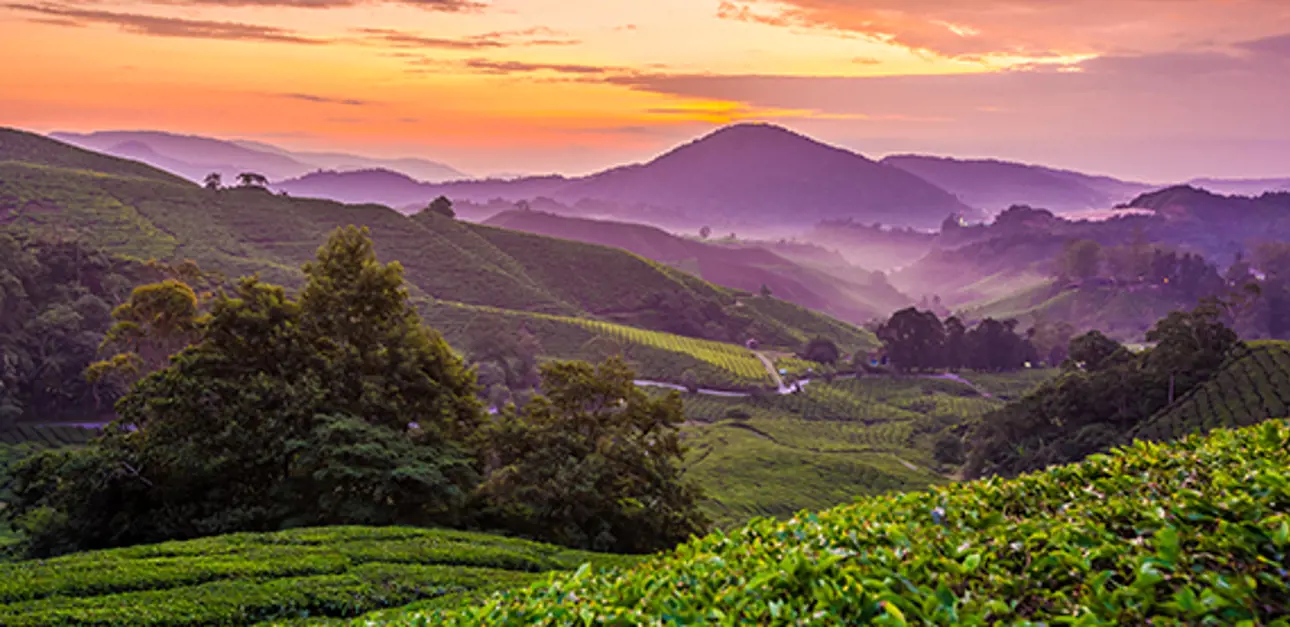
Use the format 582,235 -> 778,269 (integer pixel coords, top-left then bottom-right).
4,227 -> 707,556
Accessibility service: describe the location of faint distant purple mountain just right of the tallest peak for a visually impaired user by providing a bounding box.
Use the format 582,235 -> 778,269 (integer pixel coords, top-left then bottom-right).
881,155 -> 1155,213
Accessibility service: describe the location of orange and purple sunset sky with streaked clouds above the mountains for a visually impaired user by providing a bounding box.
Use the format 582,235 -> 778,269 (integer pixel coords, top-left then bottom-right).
0,0 -> 1290,183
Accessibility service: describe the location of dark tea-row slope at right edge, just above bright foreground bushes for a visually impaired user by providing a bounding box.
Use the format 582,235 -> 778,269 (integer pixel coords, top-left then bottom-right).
1127,342 -> 1290,441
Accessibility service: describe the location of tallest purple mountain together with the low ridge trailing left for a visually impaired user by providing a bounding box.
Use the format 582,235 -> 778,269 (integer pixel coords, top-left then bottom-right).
281,124 -> 975,228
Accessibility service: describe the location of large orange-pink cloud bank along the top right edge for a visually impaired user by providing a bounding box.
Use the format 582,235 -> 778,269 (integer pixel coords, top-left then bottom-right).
717,0 -> 1290,59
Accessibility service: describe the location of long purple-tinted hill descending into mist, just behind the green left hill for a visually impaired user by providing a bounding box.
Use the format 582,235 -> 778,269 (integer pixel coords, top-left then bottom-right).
485,210 -> 909,324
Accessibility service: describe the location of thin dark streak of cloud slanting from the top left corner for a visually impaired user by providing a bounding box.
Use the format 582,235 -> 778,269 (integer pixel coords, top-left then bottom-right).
0,4 -> 328,44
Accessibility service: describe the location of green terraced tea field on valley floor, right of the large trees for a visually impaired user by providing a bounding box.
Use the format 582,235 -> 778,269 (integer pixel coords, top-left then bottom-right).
670,373 -> 1051,528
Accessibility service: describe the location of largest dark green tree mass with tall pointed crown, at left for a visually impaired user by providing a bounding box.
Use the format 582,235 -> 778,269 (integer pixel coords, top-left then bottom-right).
6,227 -> 481,553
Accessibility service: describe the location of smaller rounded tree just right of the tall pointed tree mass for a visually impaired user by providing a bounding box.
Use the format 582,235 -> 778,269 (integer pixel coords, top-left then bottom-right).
480,359 -> 708,553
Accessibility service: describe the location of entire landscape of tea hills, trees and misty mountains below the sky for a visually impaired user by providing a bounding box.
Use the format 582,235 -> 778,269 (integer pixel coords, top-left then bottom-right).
0,125 -> 1290,624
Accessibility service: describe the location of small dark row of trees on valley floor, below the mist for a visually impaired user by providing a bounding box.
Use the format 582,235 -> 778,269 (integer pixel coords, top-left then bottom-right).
876,307 -> 1075,373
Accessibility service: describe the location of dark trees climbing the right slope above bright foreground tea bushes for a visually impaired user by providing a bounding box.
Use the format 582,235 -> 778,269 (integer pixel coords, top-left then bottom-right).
965,298 -> 1242,477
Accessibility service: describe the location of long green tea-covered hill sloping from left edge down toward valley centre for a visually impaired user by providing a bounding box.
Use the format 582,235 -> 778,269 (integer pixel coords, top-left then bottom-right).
0,130 -> 872,381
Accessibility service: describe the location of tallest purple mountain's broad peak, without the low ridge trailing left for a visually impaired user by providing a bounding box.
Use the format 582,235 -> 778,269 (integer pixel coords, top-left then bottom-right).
546,124 -> 975,228
